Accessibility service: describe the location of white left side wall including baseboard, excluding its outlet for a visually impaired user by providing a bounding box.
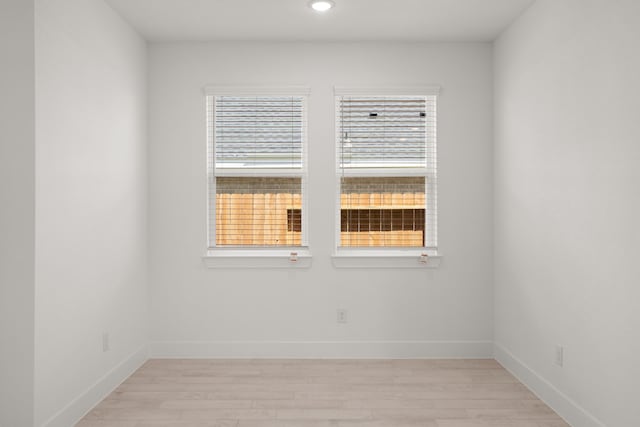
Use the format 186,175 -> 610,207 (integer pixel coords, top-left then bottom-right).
35,0 -> 148,427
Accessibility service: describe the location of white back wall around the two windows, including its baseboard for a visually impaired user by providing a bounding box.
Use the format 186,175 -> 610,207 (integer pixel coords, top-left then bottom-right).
149,43 -> 493,357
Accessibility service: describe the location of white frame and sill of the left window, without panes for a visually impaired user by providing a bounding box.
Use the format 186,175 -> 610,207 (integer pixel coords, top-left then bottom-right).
202,85 -> 311,268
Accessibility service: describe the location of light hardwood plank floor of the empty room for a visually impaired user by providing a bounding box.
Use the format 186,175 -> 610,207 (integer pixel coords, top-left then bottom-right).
77,360 -> 568,427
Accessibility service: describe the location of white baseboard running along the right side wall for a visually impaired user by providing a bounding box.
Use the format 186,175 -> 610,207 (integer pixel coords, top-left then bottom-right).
494,343 -> 606,427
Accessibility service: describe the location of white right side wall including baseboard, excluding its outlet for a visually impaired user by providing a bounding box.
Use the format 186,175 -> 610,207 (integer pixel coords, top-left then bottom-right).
495,0 -> 640,427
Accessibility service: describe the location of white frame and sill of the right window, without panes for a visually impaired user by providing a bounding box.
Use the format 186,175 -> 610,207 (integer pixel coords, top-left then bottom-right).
331,85 -> 442,268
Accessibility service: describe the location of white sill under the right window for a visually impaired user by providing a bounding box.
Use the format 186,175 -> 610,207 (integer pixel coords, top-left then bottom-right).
331,249 -> 442,268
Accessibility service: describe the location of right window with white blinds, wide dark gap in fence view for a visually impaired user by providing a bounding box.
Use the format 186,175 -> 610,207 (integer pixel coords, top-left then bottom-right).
336,87 -> 438,268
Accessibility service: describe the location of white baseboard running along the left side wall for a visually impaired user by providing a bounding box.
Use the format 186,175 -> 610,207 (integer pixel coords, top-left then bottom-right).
42,345 -> 147,427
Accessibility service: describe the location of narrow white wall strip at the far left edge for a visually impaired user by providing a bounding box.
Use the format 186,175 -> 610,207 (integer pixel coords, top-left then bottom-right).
0,0 -> 35,427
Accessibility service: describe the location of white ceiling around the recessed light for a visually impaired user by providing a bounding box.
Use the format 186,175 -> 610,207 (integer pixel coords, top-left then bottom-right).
106,0 -> 534,42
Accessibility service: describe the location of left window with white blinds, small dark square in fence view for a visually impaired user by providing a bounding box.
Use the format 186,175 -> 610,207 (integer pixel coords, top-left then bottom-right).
206,87 -> 308,268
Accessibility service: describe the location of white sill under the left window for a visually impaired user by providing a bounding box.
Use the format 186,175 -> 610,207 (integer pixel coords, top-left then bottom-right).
202,248 -> 311,268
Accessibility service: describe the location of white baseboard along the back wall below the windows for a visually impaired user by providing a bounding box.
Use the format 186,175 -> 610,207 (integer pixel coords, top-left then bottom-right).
149,341 -> 493,359
